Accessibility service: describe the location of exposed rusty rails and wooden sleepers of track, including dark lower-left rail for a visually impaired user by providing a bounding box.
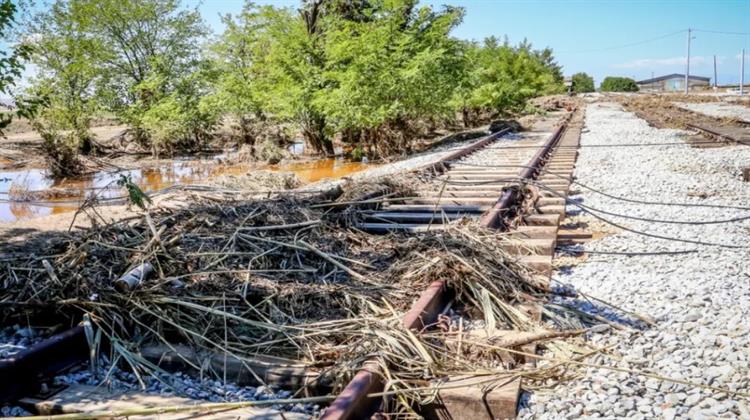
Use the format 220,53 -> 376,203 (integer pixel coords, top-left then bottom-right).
0,106 -> 582,420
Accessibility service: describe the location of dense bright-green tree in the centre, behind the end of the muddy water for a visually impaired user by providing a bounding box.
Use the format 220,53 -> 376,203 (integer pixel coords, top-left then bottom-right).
318,1 -> 462,154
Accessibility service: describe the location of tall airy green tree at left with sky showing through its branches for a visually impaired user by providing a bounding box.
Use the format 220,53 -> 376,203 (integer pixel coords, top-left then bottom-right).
71,0 -> 208,150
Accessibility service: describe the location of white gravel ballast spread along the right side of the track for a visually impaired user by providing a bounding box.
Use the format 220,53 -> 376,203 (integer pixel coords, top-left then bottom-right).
519,103 -> 750,419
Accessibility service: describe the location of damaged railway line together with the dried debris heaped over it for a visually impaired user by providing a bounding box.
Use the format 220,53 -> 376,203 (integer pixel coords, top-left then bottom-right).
0,104 -> 590,419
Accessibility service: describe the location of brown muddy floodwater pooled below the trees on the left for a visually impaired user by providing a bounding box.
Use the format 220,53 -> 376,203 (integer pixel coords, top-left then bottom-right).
0,158 -> 368,223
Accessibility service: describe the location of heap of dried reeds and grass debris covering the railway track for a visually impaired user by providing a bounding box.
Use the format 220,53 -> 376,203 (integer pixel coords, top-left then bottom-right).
0,183 -> 588,410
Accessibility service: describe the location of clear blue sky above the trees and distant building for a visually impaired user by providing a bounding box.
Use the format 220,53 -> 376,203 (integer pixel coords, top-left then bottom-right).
195,0 -> 750,84
